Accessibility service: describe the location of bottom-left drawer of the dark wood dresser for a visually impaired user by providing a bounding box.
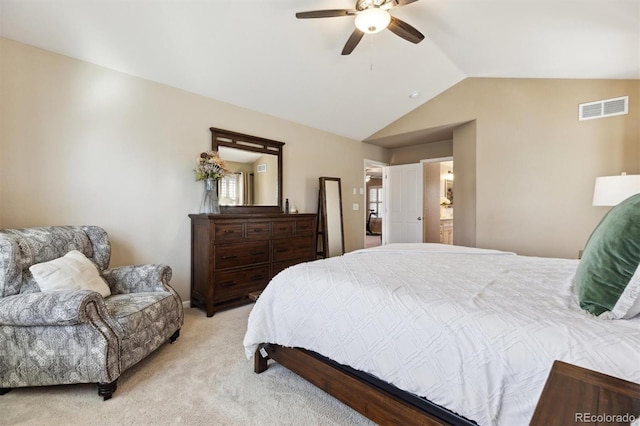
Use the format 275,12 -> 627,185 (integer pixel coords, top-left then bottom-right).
213,265 -> 269,302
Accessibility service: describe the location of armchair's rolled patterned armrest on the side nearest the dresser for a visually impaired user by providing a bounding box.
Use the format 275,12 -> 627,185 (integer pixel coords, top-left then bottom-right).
102,265 -> 172,294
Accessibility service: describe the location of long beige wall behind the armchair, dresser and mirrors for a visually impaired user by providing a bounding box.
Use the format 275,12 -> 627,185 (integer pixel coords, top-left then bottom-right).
0,39 -> 388,300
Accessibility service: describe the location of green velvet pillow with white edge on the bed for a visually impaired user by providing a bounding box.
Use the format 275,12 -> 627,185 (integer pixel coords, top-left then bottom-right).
575,194 -> 640,319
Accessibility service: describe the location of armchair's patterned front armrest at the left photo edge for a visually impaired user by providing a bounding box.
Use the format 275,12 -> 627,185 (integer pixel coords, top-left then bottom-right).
0,290 -> 107,326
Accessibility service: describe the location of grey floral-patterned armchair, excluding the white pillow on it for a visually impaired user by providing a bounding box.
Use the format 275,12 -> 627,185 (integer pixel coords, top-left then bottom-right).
0,226 -> 184,400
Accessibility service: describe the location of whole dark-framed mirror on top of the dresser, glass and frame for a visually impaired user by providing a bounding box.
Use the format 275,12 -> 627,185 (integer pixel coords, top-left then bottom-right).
210,127 -> 284,213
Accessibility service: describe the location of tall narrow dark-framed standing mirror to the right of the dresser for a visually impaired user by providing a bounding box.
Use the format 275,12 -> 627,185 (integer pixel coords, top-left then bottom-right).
318,177 -> 344,257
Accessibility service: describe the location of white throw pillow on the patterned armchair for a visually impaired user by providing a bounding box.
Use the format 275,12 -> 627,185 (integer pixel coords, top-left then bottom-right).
29,250 -> 111,297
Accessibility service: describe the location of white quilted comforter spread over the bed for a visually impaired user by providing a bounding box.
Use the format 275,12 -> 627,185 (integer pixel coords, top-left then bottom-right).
244,244 -> 640,425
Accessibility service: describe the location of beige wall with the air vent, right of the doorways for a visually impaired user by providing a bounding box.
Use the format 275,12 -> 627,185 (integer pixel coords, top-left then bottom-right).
372,78 -> 640,258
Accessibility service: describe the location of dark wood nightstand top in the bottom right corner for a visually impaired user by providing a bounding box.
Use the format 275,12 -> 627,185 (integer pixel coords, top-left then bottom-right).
531,361 -> 640,426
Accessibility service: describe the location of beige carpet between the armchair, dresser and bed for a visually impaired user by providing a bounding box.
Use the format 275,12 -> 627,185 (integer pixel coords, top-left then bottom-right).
0,305 -> 372,426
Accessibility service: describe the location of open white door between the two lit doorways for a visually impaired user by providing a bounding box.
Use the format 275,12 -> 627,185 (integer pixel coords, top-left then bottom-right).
382,163 -> 422,244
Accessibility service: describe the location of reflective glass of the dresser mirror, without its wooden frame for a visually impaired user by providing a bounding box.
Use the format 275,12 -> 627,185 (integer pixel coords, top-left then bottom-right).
218,146 -> 278,206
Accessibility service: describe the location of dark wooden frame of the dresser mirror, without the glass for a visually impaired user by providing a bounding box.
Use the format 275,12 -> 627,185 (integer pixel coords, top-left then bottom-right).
209,127 -> 284,213
